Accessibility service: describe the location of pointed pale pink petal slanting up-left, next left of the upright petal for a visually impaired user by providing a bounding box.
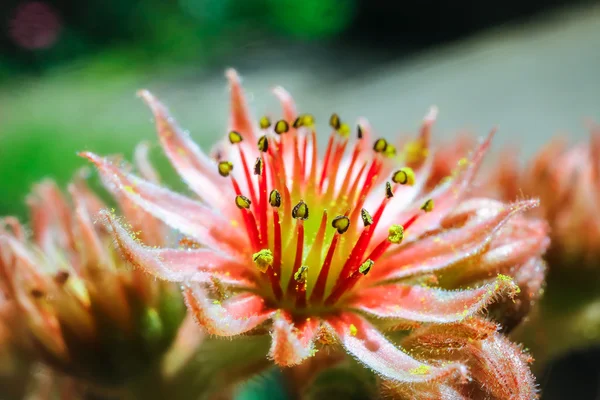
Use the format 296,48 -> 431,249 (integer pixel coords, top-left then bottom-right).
139,90 -> 231,207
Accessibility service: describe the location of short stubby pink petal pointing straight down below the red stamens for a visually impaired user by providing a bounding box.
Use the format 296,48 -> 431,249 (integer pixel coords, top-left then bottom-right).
269,311 -> 320,366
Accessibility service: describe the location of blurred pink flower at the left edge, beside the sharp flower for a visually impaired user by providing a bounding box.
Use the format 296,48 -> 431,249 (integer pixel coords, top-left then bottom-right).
0,164 -> 185,389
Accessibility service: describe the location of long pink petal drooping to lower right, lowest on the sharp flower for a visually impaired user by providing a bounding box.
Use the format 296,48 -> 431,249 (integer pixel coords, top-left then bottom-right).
326,313 -> 466,383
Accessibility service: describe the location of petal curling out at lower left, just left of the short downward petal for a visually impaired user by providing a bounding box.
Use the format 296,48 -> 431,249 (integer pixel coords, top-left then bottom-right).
184,285 -> 275,336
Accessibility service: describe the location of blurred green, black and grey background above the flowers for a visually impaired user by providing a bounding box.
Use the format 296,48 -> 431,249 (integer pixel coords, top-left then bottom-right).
0,0 -> 600,399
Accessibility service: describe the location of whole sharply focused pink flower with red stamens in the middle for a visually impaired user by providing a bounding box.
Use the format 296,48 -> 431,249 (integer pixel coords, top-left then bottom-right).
82,70 -> 547,398
